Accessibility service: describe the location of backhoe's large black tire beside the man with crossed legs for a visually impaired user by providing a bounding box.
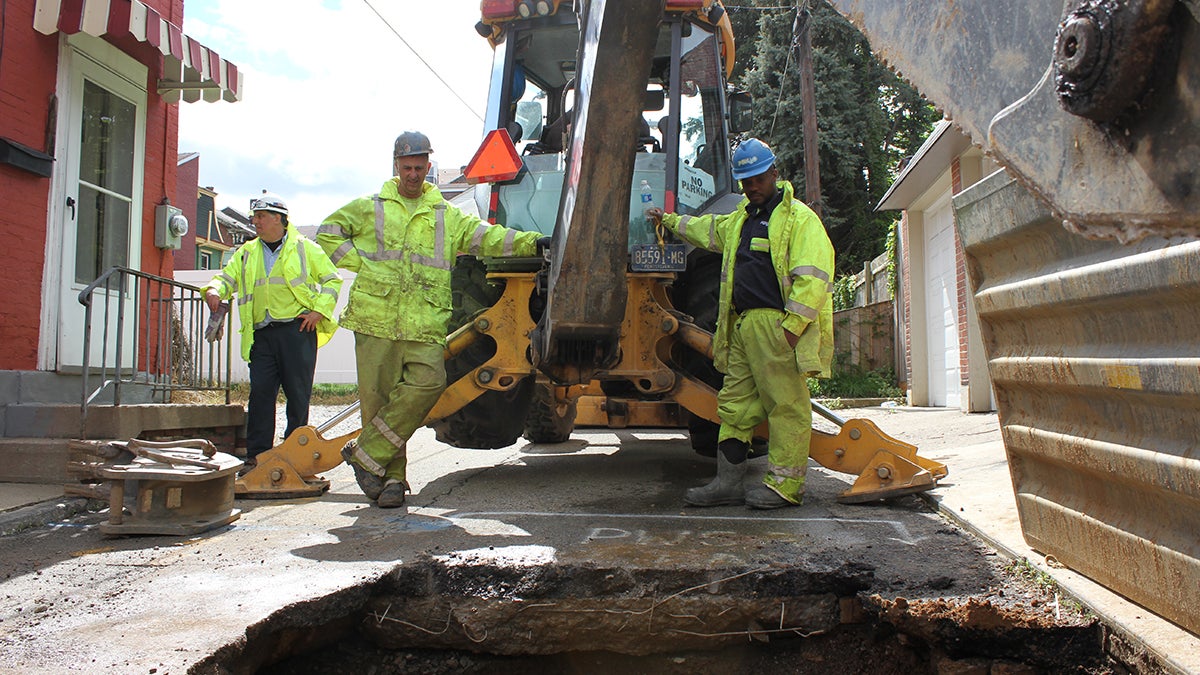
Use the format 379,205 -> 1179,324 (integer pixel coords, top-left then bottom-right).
432,256 -> 534,449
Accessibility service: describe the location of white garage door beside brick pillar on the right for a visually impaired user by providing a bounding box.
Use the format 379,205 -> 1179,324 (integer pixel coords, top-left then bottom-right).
925,197 -> 961,407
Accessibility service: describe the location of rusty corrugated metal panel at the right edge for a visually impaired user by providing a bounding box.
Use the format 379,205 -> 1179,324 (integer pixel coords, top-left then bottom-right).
954,172 -> 1200,632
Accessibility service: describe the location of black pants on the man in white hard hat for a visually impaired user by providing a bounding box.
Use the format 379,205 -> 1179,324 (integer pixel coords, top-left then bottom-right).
246,319 -> 317,458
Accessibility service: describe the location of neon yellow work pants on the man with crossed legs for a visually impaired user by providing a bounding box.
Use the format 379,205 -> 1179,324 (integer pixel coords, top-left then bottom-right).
354,333 -> 446,480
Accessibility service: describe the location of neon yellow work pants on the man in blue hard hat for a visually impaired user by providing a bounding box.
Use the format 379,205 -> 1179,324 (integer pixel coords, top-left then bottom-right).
716,310 -> 812,503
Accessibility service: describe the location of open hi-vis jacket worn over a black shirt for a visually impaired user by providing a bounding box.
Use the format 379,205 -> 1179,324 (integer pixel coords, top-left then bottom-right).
662,180 -> 834,377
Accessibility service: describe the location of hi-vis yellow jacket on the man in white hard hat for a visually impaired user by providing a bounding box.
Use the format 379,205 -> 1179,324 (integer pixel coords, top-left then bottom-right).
205,225 -> 342,362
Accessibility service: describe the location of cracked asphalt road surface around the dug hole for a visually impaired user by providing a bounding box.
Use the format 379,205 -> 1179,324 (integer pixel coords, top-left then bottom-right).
0,406 -> 1065,673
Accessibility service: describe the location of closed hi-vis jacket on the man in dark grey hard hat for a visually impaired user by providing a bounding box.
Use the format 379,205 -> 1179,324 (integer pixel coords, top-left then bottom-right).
317,178 -> 541,345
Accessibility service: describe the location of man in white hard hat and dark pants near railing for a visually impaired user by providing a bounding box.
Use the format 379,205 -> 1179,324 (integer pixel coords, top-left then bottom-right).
204,193 -> 342,466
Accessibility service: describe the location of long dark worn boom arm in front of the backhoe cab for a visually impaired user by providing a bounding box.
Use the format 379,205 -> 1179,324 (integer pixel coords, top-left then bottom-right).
533,0 -> 666,384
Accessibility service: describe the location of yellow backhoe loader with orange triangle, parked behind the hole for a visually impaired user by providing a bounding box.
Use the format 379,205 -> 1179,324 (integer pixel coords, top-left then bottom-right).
239,0 -> 947,502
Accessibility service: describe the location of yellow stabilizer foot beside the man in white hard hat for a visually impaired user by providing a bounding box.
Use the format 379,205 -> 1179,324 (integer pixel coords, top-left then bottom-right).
234,402 -> 359,500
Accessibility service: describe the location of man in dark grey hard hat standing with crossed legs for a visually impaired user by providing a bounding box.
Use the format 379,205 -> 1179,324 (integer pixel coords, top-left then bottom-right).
317,131 -> 548,508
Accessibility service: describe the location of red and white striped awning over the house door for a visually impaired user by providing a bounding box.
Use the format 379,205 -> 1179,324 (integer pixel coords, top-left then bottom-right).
34,0 -> 242,103
